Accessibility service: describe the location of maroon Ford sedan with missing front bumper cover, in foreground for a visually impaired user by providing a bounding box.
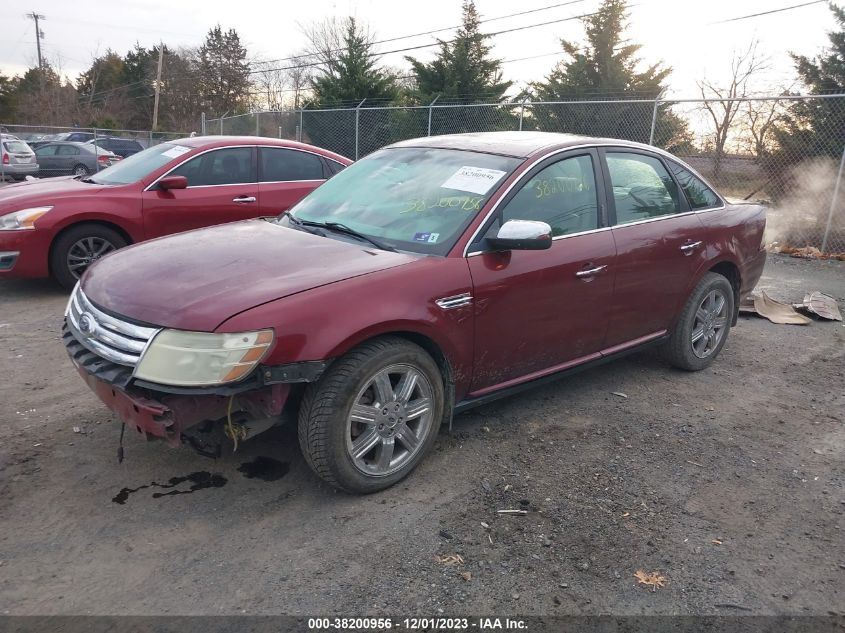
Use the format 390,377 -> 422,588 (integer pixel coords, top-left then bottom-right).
63,132 -> 765,492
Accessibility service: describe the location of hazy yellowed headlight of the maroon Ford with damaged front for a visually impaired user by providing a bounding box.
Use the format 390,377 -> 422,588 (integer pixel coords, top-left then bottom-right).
135,330 -> 274,387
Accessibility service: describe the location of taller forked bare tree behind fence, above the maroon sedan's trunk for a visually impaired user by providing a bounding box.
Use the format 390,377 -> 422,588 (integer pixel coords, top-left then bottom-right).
698,40 -> 768,180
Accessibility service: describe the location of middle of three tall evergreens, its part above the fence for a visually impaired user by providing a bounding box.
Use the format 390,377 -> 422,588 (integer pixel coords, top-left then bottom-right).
405,0 -> 512,104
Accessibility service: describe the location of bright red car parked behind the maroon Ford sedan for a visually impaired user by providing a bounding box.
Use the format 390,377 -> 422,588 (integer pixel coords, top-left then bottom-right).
0,136 -> 352,288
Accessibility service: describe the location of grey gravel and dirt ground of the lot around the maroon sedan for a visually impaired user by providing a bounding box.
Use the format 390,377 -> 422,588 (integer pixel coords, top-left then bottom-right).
0,256 -> 845,616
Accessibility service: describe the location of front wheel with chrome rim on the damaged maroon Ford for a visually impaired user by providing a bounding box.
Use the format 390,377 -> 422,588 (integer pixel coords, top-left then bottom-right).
299,336 -> 445,493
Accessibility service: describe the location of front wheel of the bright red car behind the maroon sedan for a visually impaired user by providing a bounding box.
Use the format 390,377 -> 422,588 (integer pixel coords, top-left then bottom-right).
50,224 -> 126,289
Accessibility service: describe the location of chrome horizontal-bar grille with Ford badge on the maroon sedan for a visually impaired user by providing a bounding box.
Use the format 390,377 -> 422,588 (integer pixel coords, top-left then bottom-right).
65,285 -> 158,367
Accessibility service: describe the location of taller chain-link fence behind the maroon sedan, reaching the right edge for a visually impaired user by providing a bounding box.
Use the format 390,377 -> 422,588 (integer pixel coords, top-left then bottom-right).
203,94 -> 845,253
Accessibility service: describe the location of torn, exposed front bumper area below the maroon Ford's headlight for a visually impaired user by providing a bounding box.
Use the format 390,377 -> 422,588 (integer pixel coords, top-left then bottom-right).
62,322 -> 325,455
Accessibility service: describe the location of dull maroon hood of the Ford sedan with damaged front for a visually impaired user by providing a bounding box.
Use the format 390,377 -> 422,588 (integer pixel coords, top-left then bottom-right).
82,220 -> 420,332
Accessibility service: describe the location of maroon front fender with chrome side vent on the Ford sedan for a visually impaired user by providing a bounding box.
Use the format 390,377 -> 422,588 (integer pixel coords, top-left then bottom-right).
216,257 -> 473,397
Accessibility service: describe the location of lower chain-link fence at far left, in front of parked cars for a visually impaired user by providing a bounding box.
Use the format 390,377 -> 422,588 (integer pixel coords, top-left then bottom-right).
0,123 -> 187,182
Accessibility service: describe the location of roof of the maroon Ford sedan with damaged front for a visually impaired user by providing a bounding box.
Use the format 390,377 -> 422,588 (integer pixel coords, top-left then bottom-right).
388,131 -> 659,158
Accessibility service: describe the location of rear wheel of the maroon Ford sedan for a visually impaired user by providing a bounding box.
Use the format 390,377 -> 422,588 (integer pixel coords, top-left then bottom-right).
663,272 -> 734,371
